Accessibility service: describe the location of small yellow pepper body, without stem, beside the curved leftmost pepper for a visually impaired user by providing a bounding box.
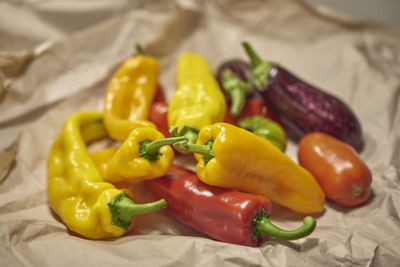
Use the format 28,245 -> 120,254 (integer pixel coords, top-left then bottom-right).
91,127 -> 179,183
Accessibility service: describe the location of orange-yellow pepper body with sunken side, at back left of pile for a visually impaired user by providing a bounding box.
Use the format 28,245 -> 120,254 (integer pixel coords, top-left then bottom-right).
104,55 -> 159,141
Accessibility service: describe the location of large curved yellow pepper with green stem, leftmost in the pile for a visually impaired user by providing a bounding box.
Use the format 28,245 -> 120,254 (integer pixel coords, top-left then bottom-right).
47,111 -> 166,239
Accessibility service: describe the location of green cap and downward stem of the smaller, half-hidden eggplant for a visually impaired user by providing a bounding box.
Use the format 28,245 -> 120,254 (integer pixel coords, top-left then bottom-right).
222,69 -> 250,117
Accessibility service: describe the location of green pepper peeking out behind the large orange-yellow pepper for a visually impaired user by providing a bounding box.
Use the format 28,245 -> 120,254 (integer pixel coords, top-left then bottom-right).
238,116 -> 286,151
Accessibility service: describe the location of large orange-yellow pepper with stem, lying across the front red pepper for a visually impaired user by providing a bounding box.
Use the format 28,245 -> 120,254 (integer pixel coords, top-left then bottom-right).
174,123 -> 325,213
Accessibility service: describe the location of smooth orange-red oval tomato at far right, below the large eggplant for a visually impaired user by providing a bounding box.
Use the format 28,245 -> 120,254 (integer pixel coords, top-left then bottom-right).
298,132 -> 372,208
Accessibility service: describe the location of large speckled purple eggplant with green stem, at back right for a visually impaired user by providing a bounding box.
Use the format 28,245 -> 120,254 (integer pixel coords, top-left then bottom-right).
243,43 -> 364,151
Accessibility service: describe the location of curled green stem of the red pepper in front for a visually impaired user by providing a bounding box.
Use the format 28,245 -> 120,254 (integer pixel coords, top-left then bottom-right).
253,209 -> 317,240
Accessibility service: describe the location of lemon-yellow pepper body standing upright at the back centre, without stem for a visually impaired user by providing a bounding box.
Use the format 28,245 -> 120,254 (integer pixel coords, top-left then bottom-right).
167,53 -> 226,142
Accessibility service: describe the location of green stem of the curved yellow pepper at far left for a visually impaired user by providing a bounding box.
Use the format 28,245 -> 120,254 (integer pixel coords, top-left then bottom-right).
108,192 -> 167,231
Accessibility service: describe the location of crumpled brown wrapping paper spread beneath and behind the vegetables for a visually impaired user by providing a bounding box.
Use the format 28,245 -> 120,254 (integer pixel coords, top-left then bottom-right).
0,0 -> 400,266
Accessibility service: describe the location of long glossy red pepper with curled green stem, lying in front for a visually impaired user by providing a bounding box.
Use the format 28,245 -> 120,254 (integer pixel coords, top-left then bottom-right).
146,165 -> 316,247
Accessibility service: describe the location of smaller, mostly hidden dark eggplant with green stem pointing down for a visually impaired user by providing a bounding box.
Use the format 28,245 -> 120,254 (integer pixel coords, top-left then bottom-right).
217,59 -> 255,117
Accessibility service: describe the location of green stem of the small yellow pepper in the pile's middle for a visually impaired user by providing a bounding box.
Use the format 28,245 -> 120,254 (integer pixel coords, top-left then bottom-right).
139,136 -> 186,161
